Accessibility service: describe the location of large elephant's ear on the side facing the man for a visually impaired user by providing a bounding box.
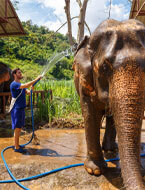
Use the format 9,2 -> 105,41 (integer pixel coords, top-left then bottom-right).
73,36 -> 95,96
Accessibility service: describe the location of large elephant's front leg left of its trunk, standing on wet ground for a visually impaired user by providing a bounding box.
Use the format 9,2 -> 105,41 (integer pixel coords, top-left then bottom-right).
80,93 -> 107,175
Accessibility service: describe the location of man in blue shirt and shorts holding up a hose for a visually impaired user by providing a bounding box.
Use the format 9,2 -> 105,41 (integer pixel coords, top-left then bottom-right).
10,68 -> 42,153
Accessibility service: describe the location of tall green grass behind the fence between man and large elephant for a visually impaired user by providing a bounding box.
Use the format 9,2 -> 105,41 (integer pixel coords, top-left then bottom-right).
35,80 -> 81,121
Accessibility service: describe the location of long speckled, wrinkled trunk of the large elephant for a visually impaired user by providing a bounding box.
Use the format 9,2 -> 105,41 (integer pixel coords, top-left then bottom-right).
109,64 -> 145,190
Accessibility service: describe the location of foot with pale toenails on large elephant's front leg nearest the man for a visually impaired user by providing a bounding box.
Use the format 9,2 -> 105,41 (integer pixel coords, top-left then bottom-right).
84,158 -> 107,176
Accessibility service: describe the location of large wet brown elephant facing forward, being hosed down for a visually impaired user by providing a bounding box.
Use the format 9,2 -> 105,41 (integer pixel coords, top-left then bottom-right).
73,19 -> 145,190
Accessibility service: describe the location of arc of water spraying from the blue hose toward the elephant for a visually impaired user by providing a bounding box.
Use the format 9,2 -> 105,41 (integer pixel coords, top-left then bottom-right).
41,46 -> 75,77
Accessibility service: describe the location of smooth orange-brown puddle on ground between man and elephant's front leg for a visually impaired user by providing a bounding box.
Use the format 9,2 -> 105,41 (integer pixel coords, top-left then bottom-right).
0,129 -> 86,163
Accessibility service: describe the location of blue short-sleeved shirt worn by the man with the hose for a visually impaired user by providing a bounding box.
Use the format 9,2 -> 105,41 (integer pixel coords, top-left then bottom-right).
10,81 -> 26,108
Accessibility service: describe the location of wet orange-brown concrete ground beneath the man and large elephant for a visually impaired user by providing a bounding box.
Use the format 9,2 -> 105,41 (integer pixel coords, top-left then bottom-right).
0,122 -> 145,190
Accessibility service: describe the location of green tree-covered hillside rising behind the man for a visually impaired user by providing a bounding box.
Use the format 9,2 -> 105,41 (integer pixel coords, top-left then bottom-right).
0,21 -> 73,80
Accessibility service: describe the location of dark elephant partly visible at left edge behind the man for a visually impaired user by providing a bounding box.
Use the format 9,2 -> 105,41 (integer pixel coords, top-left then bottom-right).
0,62 -> 14,114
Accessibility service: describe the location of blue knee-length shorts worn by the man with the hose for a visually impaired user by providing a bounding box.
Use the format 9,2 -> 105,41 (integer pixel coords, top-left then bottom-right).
11,108 -> 25,129
